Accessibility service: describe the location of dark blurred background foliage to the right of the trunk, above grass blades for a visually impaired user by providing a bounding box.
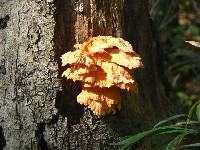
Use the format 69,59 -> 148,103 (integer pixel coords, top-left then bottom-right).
149,0 -> 200,110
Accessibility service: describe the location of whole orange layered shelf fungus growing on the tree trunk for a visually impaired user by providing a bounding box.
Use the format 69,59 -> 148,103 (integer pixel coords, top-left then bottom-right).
61,36 -> 143,116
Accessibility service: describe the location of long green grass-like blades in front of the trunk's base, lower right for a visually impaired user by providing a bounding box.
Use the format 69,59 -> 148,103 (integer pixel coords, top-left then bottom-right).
111,100 -> 200,150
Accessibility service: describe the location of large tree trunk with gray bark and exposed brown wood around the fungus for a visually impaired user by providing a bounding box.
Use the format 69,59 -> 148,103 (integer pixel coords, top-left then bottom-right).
0,0 -> 170,150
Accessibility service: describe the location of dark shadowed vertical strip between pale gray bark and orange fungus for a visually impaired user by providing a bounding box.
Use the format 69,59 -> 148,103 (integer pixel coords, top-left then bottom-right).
54,0 -> 83,126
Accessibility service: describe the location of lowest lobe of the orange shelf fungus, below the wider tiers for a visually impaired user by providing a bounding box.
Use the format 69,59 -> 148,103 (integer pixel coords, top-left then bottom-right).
77,87 -> 121,116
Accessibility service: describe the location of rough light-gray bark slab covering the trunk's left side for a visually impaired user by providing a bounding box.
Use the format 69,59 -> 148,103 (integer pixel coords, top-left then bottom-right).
0,0 -> 59,150
